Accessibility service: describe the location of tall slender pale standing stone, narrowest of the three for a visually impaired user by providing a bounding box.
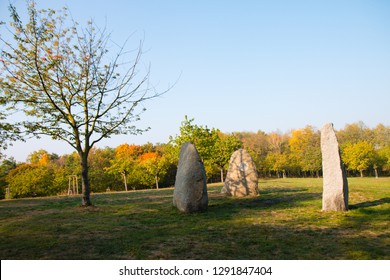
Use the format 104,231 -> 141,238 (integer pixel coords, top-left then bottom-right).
321,123 -> 348,211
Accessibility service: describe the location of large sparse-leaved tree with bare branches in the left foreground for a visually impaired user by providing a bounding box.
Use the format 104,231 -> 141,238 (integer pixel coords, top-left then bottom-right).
0,1 -> 165,206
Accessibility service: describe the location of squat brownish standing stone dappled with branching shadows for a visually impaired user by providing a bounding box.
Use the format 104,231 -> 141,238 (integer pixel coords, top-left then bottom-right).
221,149 -> 259,196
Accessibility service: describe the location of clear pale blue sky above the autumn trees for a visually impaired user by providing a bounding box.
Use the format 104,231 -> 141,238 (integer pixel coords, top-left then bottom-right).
0,0 -> 390,161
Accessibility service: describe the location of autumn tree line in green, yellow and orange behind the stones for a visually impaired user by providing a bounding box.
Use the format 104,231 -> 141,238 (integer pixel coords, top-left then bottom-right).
0,117 -> 390,198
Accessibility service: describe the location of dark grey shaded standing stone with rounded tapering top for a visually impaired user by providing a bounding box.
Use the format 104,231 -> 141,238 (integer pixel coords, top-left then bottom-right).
173,142 -> 208,213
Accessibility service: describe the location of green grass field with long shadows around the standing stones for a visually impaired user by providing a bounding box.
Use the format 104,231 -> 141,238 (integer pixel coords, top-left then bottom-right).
0,178 -> 390,260
